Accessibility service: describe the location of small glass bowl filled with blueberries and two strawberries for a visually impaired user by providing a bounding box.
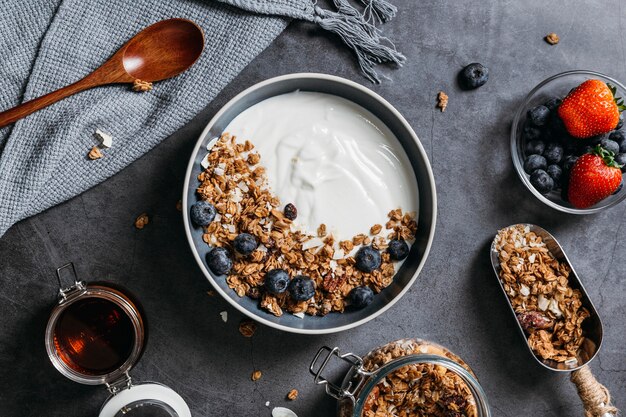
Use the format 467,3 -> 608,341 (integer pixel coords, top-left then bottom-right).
511,71 -> 626,214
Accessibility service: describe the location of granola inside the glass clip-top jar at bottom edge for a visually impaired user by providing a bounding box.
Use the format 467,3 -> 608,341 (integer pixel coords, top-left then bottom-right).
354,339 -> 478,417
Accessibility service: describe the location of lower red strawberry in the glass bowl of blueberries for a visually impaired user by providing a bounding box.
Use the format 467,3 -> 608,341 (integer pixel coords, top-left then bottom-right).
567,145 -> 622,208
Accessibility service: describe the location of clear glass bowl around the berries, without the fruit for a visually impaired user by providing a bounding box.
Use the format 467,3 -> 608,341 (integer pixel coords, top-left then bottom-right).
511,70 -> 626,214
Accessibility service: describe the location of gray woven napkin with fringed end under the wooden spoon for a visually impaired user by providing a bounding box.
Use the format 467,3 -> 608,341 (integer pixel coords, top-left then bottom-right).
0,0 -> 404,236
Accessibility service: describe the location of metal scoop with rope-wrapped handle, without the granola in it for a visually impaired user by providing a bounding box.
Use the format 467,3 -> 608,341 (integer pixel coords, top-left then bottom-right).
490,224 -> 618,417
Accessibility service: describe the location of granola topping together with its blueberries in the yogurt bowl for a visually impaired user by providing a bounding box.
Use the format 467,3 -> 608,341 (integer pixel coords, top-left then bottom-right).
191,133 -> 417,316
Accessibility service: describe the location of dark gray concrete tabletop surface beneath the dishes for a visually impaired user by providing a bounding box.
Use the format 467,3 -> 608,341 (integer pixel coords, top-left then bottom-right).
0,0 -> 626,417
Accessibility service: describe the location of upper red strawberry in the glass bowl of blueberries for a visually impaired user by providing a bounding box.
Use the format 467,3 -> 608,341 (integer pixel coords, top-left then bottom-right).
558,80 -> 624,139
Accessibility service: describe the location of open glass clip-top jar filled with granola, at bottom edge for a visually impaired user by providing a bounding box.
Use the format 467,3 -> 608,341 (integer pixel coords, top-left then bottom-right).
310,339 -> 491,417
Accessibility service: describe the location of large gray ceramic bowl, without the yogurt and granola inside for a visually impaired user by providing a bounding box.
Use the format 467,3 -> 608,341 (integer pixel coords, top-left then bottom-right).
183,73 -> 437,334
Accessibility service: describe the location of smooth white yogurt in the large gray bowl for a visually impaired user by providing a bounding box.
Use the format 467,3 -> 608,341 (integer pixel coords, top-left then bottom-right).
225,91 -> 419,240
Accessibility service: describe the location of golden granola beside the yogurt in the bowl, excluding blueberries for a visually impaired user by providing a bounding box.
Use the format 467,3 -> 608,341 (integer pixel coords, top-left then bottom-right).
197,133 -> 417,316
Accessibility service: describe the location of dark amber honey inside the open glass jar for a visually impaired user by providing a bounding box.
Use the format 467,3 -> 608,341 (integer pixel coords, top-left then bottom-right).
54,297 -> 135,375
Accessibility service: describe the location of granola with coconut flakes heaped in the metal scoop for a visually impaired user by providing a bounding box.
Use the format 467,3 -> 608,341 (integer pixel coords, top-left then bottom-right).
495,225 -> 589,362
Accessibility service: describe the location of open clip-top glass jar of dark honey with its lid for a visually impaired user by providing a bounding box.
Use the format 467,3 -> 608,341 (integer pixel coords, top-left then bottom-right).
45,263 -> 191,417
